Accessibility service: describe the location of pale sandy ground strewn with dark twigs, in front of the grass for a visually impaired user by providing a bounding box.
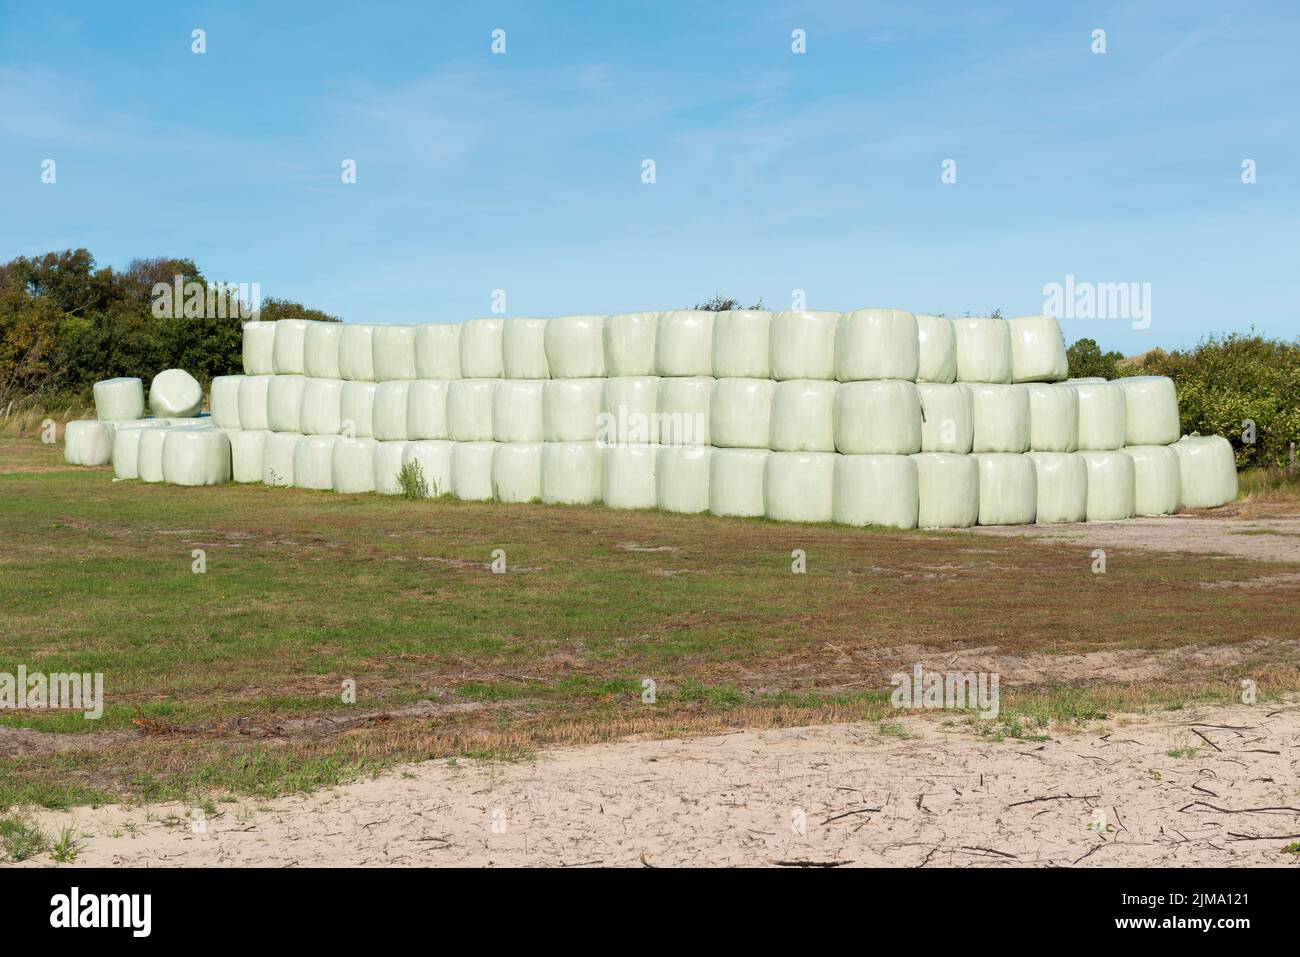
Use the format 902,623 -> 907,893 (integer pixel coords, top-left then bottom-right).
20,698 -> 1300,867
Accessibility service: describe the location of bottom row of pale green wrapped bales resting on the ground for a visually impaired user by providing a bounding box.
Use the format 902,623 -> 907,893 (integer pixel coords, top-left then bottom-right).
101,420 -> 1236,528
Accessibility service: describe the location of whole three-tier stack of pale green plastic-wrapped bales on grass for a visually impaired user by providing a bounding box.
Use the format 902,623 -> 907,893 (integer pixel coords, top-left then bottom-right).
69,309 -> 1236,528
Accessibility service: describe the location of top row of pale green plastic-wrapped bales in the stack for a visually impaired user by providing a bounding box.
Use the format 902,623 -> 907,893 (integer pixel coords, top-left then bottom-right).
243,309 -> 1069,382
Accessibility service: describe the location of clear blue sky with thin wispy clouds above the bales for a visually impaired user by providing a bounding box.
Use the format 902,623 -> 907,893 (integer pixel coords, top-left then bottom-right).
0,0 -> 1300,352
